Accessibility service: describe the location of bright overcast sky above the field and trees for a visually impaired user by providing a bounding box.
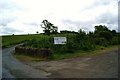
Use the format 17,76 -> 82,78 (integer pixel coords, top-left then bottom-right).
0,0 -> 119,35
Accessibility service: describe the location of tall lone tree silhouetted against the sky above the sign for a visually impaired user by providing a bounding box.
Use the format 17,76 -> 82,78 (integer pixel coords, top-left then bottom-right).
41,20 -> 58,35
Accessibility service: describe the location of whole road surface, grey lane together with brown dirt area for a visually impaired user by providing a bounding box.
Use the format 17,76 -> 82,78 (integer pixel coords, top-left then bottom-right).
2,47 -> 118,78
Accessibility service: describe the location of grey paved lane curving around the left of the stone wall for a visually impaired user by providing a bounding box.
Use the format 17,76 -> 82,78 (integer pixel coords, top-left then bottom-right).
2,47 -> 50,78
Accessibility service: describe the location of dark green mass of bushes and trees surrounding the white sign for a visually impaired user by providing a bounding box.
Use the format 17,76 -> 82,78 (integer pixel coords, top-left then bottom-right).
23,25 -> 120,54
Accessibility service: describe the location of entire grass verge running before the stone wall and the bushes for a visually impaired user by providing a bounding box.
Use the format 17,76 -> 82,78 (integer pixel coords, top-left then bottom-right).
13,46 -> 118,62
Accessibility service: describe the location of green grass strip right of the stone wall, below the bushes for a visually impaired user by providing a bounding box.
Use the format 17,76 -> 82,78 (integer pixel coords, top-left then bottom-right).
53,46 -> 118,60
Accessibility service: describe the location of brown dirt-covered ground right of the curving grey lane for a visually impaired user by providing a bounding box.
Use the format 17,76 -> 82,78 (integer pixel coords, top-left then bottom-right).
27,51 -> 118,78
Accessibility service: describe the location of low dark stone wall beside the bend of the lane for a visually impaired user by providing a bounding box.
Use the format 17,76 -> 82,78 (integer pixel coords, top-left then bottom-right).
15,46 -> 52,57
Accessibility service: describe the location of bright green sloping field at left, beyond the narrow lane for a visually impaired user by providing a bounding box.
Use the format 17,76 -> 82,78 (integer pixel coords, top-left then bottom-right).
2,34 -> 46,48
